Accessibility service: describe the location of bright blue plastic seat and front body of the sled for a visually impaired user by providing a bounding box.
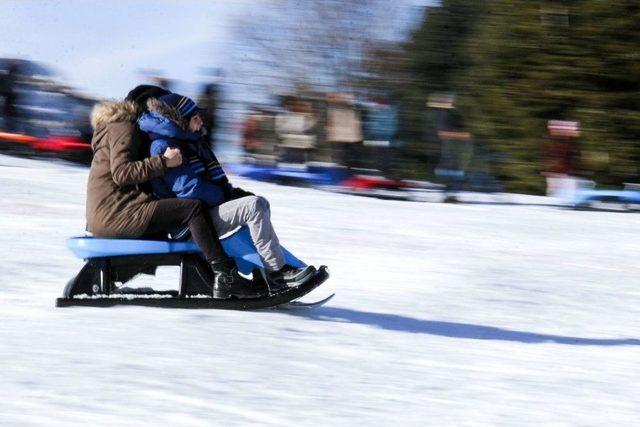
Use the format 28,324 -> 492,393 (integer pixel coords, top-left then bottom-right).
67,226 -> 306,273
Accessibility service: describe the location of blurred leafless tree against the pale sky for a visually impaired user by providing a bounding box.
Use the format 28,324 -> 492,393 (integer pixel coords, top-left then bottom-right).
230,0 -> 394,93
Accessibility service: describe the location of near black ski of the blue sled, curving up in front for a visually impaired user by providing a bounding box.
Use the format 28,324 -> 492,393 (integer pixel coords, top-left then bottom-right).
56,266 -> 329,310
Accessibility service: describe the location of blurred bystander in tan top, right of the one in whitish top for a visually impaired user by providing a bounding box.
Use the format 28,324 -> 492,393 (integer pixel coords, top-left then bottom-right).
326,93 -> 362,167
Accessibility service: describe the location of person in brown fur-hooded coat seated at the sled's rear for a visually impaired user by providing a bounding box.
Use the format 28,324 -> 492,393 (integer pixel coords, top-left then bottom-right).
86,85 -> 260,298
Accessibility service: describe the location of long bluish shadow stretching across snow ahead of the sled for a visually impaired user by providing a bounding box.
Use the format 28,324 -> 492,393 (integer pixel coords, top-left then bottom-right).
293,307 -> 640,346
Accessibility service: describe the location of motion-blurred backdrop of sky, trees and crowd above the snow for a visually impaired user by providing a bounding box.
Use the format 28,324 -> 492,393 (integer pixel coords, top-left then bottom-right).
0,0 -> 640,206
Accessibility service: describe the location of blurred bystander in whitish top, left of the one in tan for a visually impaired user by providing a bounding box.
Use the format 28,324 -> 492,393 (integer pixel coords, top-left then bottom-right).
275,97 -> 317,163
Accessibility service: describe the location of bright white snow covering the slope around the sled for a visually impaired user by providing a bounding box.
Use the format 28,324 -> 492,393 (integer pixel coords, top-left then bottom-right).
0,156 -> 640,426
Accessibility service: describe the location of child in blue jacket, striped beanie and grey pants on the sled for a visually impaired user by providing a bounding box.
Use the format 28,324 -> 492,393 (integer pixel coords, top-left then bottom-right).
138,93 -> 315,289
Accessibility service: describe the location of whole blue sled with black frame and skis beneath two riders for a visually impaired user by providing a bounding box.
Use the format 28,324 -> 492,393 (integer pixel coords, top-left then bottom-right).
56,227 -> 329,310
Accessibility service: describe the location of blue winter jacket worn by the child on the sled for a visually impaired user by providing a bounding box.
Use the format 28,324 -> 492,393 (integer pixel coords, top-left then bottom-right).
138,111 -> 233,207
